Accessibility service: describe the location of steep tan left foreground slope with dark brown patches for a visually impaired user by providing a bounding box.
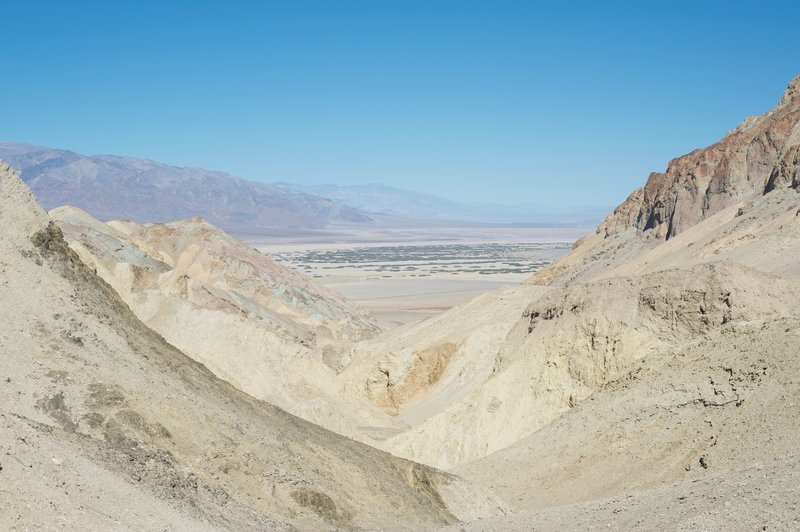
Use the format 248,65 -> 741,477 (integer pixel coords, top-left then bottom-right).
0,164 -> 500,530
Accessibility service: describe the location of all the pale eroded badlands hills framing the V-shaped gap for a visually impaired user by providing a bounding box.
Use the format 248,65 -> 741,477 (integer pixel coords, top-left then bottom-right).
0,78 -> 800,530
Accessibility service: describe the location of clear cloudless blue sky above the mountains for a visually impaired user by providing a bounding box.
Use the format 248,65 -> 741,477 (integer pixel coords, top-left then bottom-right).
0,0 -> 800,206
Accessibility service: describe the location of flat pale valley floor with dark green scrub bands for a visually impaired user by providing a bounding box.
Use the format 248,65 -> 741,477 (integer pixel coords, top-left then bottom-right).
243,227 -> 592,328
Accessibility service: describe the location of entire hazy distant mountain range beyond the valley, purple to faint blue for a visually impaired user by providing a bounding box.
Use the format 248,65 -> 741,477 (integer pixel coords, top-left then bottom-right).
0,142 -> 608,233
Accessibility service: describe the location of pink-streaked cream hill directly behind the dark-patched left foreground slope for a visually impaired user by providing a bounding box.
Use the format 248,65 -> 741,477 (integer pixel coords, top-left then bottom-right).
51,207 -> 397,437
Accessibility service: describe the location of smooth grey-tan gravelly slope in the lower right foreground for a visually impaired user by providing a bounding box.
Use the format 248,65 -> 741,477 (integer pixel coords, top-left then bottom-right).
453,318 -> 800,530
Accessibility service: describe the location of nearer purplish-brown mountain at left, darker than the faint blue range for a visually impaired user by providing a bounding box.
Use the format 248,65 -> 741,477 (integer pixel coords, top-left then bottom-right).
0,142 -> 372,233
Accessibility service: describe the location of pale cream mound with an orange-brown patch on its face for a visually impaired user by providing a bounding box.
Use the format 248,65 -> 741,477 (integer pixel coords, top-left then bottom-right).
337,286 -> 547,425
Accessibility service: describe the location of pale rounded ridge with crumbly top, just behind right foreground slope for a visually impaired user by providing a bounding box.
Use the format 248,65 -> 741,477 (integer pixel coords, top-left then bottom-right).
381,263 -> 800,469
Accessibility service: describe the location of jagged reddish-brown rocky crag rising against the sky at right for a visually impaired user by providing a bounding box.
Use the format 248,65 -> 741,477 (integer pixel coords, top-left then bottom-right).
527,77 -> 800,285
